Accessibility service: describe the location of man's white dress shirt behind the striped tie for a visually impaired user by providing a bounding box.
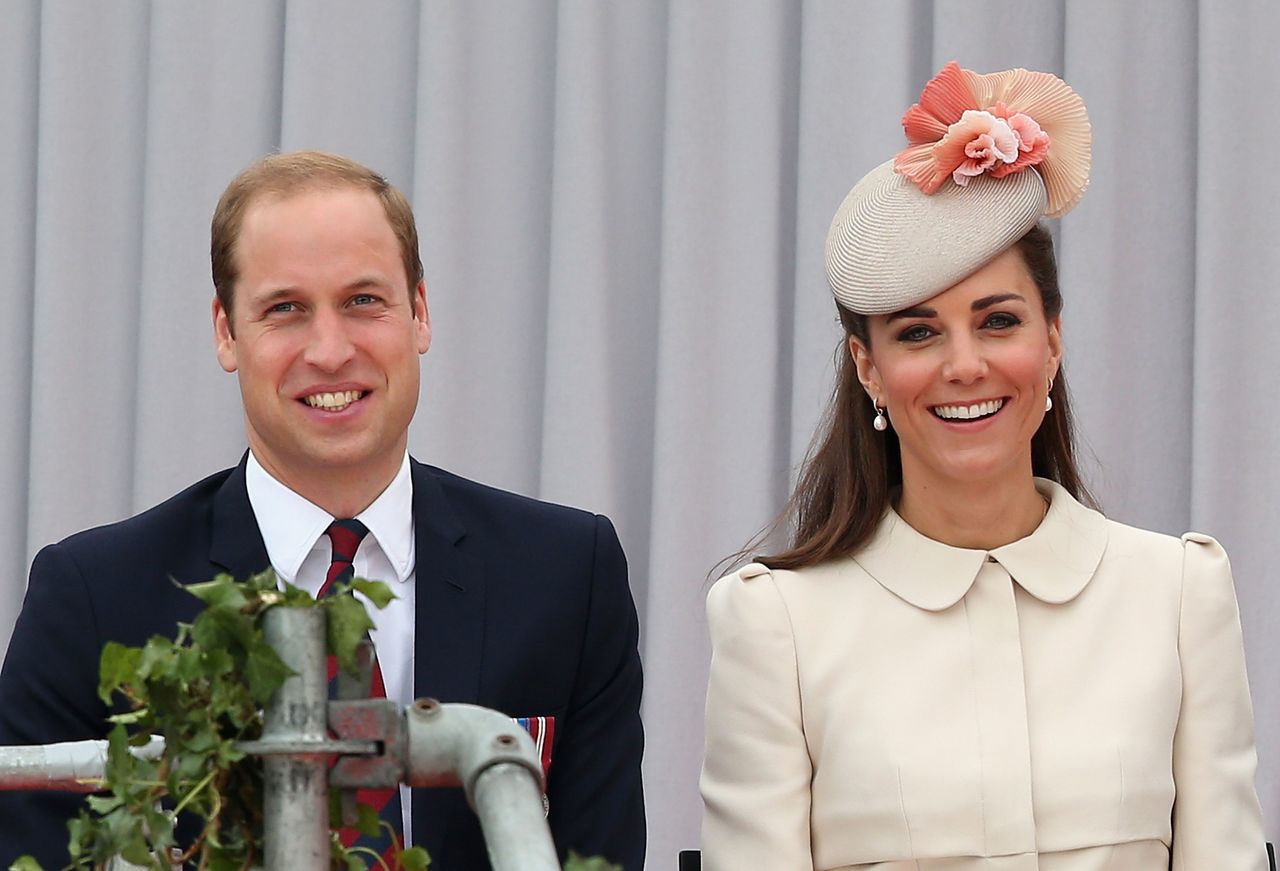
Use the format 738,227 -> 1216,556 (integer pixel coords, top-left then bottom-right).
244,451 -> 416,845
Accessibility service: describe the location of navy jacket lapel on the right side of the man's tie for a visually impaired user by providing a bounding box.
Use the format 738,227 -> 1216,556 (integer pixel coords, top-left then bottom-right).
410,459 -> 485,703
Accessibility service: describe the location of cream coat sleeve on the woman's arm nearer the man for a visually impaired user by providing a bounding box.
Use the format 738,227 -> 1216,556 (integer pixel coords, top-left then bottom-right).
701,564 -> 813,871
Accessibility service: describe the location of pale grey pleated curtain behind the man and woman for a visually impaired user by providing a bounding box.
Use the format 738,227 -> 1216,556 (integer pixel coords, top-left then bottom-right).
0,0 -> 1280,870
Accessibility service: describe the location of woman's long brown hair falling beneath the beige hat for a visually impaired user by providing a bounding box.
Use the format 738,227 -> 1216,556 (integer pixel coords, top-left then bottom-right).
747,224 -> 1096,569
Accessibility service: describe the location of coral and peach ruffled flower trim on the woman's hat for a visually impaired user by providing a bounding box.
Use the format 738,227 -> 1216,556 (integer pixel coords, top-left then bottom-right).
893,61 -> 1092,218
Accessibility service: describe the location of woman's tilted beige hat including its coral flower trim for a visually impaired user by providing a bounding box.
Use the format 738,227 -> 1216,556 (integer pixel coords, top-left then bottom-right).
826,61 -> 1091,315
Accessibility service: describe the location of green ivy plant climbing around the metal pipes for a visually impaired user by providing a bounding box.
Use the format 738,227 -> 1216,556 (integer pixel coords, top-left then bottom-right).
9,569 -> 621,871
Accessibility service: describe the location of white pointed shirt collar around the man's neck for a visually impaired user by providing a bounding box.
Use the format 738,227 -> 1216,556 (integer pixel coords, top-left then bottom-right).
244,451 -> 413,584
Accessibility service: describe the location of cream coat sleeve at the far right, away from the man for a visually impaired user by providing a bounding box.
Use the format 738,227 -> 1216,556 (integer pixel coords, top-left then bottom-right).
1172,533 -> 1267,871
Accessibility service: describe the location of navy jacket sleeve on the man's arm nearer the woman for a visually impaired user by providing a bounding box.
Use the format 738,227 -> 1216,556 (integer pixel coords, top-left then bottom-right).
548,516 -> 645,871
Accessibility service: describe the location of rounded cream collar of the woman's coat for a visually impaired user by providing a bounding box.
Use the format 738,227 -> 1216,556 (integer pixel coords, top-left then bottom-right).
854,478 -> 1107,611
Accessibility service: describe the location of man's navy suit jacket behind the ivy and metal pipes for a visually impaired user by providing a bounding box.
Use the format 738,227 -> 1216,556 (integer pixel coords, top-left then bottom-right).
0,461 -> 645,871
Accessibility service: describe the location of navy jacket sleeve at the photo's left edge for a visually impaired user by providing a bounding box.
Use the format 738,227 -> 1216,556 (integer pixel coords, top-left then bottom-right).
0,544 -> 108,868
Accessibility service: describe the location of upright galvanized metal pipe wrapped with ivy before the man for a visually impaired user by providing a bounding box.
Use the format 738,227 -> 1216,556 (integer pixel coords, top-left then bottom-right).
262,607 -> 329,871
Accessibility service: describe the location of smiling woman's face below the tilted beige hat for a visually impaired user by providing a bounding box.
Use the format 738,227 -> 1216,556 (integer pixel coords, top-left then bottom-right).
849,248 -> 1062,485
